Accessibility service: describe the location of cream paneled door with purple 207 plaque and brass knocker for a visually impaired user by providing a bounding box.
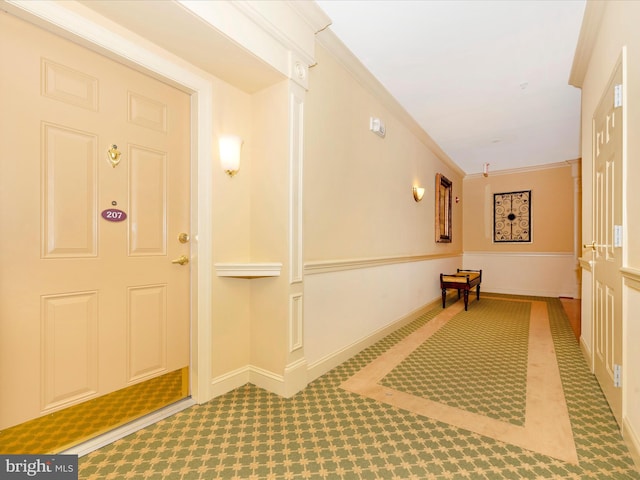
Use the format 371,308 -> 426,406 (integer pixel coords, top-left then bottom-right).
0,13 -> 190,430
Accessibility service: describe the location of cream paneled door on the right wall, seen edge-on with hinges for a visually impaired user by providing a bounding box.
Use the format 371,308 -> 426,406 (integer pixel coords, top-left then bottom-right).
592,57 -> 623,424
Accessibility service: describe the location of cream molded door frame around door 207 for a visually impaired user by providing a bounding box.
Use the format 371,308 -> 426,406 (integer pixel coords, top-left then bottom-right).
0,0 -> 213,403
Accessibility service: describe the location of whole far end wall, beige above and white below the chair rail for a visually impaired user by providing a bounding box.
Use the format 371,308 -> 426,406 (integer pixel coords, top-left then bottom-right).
461,166 -> 580,298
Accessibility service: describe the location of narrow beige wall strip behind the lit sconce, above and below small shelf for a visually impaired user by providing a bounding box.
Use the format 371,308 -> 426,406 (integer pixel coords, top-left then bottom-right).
208,78 -> 253,377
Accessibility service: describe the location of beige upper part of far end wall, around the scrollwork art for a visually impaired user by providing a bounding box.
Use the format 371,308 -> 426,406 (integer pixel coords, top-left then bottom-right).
462,163 -> 575,253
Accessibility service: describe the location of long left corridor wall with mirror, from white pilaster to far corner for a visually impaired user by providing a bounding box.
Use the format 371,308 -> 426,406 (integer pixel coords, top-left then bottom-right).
303,43 -> 462,378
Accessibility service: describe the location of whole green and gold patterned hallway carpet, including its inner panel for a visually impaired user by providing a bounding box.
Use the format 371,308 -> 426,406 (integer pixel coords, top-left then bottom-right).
79,295 -> 640,480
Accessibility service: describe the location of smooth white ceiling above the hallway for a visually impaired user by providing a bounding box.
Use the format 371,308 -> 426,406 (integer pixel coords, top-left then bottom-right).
317,0 -> 585,174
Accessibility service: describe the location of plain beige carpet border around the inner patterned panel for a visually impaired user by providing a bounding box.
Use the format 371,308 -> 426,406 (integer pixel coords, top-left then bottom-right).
341,296 -> 578,464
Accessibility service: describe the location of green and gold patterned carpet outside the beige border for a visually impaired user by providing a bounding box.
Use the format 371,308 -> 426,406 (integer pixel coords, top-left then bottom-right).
79,295 -> 640,480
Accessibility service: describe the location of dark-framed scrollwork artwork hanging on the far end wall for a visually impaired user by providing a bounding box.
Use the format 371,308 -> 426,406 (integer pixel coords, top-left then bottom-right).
493,190 -> 531,243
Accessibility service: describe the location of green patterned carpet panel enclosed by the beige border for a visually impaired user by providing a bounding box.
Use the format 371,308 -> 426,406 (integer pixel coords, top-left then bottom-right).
380,298 -> 531,426
